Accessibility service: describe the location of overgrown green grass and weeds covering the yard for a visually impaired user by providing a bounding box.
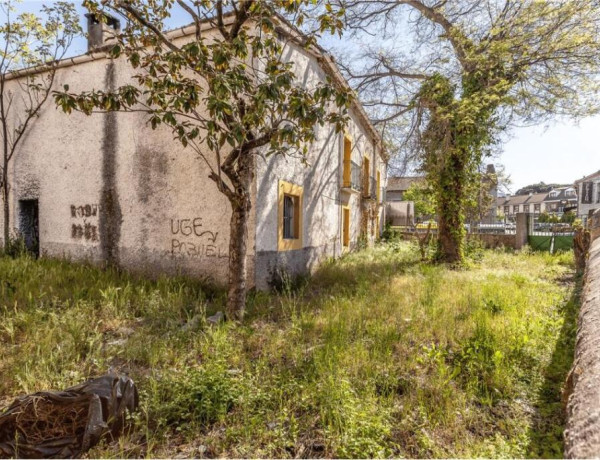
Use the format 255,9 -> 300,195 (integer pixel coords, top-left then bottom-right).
0,243 -> 578,457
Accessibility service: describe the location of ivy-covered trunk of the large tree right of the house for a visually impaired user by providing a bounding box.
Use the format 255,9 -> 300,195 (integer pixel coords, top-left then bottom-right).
437,152 -> 467,264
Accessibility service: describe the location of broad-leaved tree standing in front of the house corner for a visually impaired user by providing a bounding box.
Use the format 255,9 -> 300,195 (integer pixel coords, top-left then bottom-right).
56,0 -> 351,318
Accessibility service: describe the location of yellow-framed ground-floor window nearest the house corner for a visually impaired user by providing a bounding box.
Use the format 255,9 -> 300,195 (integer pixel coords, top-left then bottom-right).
277,180 -> 304,251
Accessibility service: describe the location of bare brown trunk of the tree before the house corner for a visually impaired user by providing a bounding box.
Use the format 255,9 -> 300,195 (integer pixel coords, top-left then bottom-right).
227,200 -> 250,320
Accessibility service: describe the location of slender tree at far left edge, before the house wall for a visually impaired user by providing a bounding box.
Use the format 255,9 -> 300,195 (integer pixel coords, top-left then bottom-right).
0,0 -> 81,252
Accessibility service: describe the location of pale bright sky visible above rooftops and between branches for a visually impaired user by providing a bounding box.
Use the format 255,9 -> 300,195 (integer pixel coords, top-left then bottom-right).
5,0 -> 600,192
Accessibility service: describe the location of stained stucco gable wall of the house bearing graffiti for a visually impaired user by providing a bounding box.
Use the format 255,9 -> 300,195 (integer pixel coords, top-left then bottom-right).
0,44 -> 254,288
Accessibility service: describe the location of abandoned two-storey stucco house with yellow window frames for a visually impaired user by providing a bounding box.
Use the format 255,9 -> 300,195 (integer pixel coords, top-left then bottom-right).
0,13 -> 386,288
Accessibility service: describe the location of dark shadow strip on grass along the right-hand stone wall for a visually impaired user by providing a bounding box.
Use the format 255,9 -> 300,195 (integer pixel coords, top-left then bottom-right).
527,277 -> 582,458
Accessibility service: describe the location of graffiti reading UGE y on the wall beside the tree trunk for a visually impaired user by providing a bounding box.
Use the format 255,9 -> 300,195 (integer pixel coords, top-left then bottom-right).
170,217 -> 229,259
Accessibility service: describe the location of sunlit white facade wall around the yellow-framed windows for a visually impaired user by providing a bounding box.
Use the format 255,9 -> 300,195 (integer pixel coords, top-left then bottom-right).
256,43 -> 386,287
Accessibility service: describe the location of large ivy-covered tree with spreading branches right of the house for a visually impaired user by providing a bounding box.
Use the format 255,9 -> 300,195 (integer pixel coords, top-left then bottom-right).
338,0 -> 600,263
